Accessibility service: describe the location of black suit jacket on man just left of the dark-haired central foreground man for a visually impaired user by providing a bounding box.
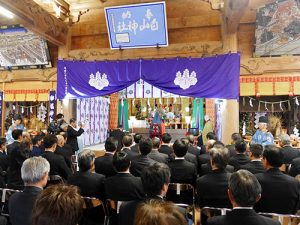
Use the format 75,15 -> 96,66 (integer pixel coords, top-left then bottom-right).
105,173 -> 144,201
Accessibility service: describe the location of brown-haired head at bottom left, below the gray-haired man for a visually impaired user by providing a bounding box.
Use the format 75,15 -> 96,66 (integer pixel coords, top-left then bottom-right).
32,185 -> 83,225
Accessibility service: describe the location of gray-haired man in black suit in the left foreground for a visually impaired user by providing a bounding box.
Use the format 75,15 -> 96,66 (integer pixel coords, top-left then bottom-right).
8,157 -> 50,225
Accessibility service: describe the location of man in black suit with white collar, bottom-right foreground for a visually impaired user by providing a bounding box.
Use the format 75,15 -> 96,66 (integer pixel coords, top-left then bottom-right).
207,170 -> 280,225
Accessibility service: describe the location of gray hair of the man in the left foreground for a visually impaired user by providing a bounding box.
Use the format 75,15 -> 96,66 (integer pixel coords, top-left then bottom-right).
21,157 -> 50,184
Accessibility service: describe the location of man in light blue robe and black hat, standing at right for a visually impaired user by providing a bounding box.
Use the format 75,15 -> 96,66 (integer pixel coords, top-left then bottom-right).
251,116 -> 274,146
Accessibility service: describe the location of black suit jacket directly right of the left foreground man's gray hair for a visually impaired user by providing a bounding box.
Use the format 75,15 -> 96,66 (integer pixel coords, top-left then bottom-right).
42,151 -> 72,180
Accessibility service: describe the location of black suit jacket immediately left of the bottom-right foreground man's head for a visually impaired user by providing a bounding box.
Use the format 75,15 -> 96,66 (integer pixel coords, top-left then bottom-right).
197,170 -> 231,208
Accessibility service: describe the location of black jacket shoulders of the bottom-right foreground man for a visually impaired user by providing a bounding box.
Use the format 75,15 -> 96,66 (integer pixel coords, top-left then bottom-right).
207,209 -> 280,225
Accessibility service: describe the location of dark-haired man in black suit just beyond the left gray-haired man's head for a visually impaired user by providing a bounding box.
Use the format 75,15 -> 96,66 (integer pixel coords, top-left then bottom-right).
42,134 -> 72,180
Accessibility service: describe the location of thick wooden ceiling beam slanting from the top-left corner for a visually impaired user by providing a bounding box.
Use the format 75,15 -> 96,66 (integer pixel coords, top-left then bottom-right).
0,0 -> 68,46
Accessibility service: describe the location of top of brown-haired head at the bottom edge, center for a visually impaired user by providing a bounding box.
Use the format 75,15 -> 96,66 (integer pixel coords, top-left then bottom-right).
134,200 -> 187,225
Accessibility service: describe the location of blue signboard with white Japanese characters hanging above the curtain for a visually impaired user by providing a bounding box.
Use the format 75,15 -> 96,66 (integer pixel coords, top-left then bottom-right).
105,2 -> 168,49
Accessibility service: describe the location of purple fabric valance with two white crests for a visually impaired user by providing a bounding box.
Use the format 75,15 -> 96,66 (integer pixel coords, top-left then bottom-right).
57,53 -> 240,99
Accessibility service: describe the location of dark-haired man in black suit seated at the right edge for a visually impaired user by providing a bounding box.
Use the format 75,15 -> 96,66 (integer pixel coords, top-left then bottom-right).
255,145 -> 300,214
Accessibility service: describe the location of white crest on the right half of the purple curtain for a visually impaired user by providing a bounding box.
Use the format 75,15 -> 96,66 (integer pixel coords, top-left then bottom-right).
174,69 -> 198,90
